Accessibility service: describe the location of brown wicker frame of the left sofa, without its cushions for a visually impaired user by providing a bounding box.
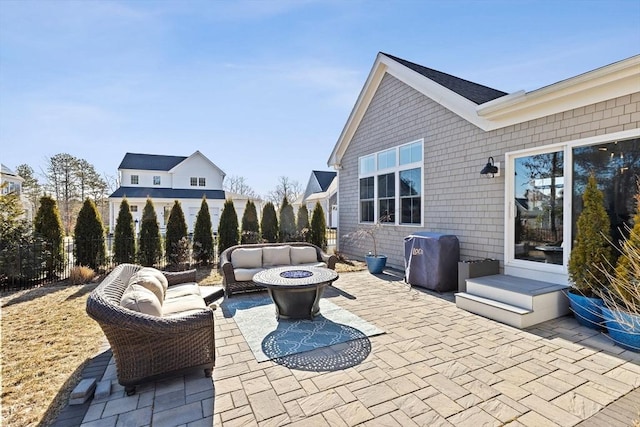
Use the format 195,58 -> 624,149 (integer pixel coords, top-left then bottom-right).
86,264 -> 215,395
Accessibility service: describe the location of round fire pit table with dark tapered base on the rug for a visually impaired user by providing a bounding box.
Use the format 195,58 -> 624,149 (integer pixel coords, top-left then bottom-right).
253,266 -> 338,319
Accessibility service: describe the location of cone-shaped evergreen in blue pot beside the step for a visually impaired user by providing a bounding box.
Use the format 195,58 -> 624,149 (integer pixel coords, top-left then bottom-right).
567,174 -> 612,329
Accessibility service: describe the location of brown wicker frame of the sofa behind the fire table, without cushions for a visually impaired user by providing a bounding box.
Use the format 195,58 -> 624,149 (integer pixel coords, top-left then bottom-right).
220,242 -> 338,298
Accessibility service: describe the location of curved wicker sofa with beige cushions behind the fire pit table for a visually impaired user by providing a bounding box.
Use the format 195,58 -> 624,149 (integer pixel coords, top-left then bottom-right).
220,242 -> 337,298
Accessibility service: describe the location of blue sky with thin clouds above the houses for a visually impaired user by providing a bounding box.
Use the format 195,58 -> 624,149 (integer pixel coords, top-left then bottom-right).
0,0 -> 640,195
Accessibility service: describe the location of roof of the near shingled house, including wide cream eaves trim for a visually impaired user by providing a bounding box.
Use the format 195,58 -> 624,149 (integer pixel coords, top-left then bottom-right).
327,52 -> 640,169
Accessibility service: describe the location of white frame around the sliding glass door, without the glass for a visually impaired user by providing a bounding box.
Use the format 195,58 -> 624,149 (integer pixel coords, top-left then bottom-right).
504,129 -> 640,283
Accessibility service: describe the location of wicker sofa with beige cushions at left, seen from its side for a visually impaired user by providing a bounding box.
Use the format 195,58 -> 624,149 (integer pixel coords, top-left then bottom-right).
86,264 -> 221,395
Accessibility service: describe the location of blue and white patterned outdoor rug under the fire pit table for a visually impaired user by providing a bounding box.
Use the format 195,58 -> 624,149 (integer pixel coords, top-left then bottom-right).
221,294 -> 384,362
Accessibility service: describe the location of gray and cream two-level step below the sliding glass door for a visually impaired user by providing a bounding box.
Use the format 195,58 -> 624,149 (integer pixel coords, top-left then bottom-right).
455,274 -> 569,328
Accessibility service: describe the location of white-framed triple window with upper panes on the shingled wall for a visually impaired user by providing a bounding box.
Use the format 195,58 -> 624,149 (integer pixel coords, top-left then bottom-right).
358,139 -> 424,225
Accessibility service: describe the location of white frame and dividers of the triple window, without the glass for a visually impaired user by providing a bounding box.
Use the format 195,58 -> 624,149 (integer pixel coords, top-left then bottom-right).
357,138 -> 425,228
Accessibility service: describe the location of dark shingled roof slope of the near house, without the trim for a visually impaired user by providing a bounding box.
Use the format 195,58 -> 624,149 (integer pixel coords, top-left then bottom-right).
380,52 -> 507,105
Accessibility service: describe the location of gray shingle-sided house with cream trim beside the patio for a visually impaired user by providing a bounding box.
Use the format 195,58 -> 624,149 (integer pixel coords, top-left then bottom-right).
328,52 -> 640,326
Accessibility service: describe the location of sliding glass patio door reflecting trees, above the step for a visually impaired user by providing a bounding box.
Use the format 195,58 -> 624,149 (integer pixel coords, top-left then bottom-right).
505,137 -> 640,274
